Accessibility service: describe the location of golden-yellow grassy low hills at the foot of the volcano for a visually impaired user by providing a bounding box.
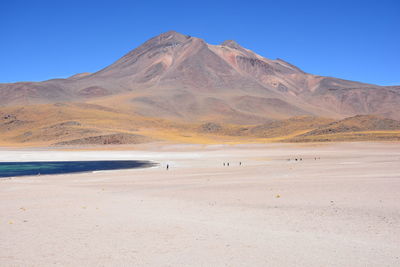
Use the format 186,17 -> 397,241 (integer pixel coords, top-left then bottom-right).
0,103 -> 400,146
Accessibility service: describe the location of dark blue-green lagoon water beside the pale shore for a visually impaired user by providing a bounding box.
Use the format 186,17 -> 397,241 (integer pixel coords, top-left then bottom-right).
0,160 -> 156,178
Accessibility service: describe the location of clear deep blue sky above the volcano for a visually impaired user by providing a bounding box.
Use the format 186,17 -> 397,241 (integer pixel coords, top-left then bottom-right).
0,0 -> 400,85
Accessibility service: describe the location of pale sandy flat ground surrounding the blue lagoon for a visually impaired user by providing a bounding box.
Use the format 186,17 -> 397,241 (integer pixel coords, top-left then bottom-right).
0,143 -> 400,266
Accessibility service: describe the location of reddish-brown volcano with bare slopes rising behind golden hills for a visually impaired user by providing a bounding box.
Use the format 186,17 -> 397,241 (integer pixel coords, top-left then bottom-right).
0,31 -> 400,147
